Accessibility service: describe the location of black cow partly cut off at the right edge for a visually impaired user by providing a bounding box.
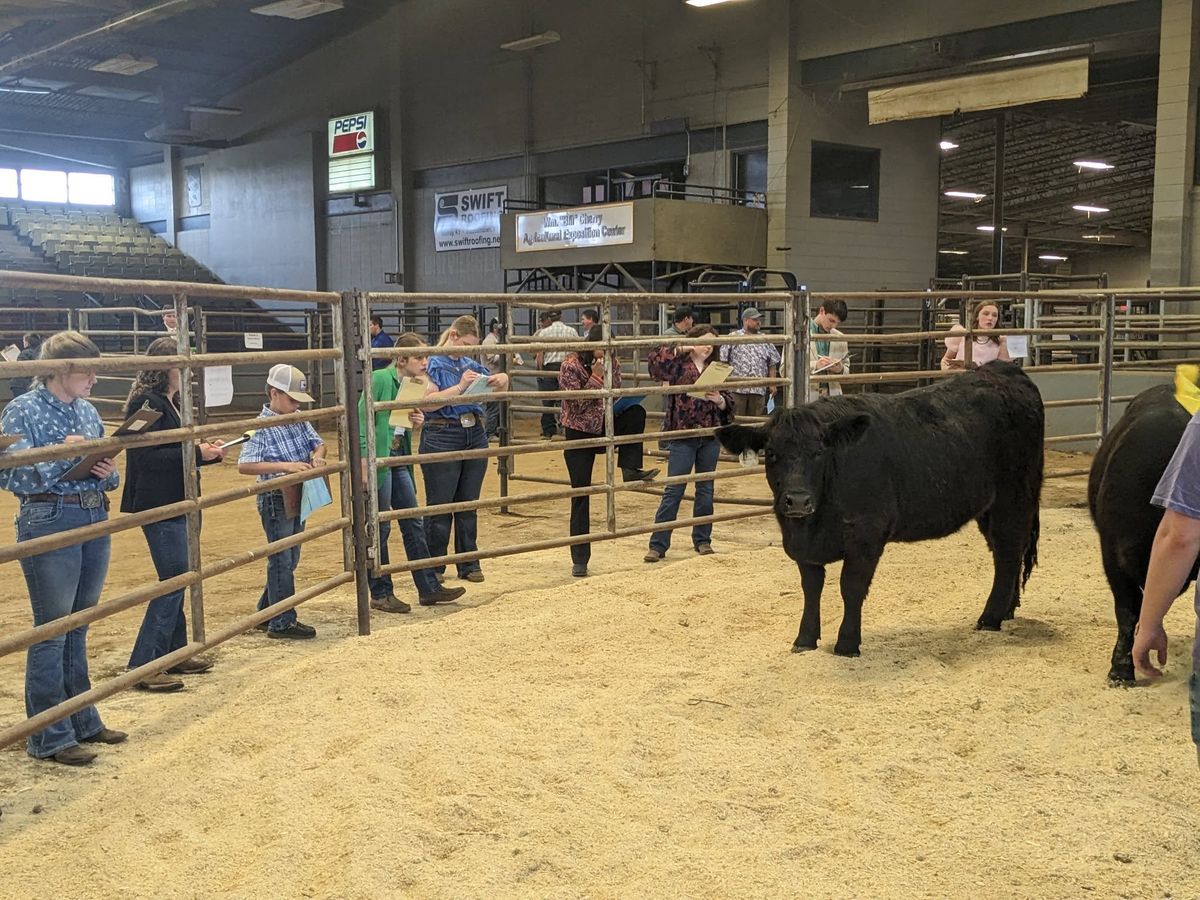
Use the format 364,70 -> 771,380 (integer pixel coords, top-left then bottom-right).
1087,384 -> 1196,684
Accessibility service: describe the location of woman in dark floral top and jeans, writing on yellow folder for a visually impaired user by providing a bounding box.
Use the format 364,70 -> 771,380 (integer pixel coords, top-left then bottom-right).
642,325 -> 733,563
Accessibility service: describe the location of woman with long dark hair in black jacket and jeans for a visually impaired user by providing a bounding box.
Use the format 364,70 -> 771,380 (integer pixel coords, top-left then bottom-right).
121,337 -> 224,692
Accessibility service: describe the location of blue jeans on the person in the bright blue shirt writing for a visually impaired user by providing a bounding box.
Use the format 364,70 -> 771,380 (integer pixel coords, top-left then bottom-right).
421,422 -> 487,578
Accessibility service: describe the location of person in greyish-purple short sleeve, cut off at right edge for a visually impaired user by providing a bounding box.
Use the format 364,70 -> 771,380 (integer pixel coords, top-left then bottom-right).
1133,413 -> 1200,757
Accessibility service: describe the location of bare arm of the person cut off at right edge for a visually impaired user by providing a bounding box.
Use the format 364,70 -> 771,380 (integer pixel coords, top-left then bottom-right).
1133,509 -> 1200,678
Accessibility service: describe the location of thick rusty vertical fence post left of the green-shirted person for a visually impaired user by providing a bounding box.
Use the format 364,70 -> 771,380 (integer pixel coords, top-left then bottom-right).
334,292 -> 371,635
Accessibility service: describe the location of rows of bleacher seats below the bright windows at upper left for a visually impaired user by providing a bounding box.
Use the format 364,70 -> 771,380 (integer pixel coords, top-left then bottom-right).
0,206 -> 220,283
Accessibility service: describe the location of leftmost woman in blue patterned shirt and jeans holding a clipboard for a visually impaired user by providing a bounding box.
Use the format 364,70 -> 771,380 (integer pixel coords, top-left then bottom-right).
0,331 -> 126,766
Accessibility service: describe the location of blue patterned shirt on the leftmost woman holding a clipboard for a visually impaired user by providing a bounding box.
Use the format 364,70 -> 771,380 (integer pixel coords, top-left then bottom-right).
0,384 -> 118,494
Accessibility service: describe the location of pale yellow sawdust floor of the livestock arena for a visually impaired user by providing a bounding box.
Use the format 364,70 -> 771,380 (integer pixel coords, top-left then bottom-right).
0,441 -> 1200,898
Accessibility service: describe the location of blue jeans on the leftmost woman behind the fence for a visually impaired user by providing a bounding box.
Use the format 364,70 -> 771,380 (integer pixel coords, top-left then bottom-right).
17,500 -> 112,758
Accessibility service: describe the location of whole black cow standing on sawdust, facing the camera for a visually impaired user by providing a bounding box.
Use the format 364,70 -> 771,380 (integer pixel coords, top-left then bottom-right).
718,362 -> 1045,656
